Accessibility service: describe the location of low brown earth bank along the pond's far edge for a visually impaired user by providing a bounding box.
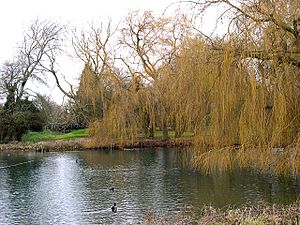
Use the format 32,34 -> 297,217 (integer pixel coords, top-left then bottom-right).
0,138 -> 193,152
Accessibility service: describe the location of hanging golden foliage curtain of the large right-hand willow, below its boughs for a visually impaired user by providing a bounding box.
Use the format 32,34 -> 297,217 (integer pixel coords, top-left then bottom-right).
172,38 -> 300,174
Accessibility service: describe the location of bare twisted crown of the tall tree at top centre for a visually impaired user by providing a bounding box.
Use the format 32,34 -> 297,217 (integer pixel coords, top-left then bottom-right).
120,11 -> 188,82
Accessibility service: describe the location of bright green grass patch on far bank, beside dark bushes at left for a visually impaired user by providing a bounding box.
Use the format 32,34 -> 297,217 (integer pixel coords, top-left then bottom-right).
22,129 -> 88,143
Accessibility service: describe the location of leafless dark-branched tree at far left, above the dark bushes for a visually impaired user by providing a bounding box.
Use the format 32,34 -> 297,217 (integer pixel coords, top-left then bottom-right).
1,20 -> 74,101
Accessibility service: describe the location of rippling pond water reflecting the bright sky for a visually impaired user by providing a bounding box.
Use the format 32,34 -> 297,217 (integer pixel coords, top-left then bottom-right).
0,149 -> 300,224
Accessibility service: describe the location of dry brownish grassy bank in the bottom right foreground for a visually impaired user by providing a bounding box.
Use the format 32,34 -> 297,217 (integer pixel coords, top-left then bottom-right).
140,200 -> 300,225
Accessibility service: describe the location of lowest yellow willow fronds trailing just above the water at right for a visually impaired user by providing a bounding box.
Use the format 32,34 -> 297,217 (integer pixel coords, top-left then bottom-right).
193,145 -> 300,176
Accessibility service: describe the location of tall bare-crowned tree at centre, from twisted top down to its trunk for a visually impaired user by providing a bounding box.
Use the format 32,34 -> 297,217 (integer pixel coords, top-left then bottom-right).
120,11 -> 189,139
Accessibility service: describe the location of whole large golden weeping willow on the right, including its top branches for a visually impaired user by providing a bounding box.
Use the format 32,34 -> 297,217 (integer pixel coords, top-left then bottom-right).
171,0 -> 300,174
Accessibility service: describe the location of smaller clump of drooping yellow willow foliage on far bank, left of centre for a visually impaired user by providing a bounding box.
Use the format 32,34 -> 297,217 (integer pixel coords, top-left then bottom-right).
89,80 -> 151,147
